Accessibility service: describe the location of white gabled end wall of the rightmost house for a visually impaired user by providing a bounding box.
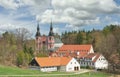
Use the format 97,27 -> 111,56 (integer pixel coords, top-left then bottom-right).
95,55 -> 108,69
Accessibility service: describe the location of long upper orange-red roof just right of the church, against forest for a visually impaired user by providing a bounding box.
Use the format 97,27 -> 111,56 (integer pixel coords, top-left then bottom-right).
58,45 -> 92,52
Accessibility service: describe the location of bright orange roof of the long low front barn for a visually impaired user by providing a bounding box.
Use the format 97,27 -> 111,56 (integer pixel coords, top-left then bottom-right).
35,57 -> 72,67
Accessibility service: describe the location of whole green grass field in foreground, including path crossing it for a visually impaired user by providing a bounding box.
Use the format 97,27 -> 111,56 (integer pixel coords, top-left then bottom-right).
0,65 -> 110,77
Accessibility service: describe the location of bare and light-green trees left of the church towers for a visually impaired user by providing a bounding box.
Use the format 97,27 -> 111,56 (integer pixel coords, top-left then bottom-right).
0,29 -> 34,66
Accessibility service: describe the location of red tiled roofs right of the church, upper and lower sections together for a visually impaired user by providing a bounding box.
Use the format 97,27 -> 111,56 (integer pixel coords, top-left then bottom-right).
56,45 -> 92,58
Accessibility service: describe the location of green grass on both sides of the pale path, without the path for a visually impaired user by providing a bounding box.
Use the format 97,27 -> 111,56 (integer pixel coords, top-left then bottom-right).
0,65 -> 109,77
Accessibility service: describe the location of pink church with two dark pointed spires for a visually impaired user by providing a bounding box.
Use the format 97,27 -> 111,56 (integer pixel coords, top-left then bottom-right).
35,22 -> 63,51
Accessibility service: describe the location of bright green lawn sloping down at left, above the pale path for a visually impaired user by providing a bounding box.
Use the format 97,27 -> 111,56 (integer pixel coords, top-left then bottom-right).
0,65 -> 69,75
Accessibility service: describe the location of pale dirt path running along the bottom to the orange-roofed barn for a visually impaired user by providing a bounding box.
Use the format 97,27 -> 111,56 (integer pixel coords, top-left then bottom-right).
0,70 -> 91,77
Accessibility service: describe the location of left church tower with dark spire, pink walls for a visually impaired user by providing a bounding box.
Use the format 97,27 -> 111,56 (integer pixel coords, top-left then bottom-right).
35,23 -> 41,52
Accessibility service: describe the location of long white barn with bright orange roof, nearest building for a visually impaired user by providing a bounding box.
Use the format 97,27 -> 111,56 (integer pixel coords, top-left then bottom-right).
29,57 -> 80,72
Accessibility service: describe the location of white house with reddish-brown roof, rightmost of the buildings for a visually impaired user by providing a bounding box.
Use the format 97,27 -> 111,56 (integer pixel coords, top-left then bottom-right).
79,53 -> 108,69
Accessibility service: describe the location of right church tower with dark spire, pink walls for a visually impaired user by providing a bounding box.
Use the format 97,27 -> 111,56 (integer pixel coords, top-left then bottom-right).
48,22 -> 55,50
